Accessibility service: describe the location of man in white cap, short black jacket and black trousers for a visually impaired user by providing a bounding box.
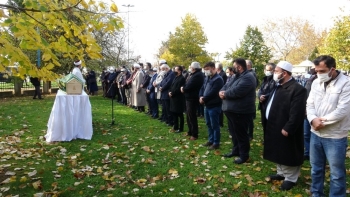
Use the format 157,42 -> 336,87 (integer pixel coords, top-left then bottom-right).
181,62 -> 204,140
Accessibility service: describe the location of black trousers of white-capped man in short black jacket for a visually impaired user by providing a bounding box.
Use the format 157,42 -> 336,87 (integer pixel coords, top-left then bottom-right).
186,99 -> 198,138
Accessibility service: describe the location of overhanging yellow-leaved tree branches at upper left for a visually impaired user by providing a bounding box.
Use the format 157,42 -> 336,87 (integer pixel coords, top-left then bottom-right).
0,0 -> 123,80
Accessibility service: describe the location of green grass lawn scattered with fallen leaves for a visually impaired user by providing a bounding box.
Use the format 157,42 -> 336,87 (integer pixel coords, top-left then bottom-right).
0,96 -> 350,197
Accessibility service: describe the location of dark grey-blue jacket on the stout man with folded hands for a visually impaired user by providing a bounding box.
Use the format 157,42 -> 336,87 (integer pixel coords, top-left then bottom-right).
220,71 -> 256,114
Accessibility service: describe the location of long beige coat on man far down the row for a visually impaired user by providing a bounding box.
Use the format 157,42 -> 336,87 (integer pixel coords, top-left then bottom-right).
131,70 -> 147,107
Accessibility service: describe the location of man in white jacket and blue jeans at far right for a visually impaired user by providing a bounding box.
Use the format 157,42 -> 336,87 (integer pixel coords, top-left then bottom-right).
306,55 -> 350,197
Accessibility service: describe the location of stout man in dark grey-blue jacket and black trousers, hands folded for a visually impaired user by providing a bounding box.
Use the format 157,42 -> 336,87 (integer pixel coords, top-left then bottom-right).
219,58 -> 256,164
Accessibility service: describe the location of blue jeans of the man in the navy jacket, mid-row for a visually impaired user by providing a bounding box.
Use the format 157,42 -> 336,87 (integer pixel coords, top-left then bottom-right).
204,106 -> 221,145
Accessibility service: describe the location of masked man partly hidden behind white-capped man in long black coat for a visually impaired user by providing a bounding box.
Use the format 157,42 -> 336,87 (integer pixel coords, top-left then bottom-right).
258,63 -> 276,133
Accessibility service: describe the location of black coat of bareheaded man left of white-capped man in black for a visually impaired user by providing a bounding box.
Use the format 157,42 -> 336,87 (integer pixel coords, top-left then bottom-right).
169,75 -> 186,113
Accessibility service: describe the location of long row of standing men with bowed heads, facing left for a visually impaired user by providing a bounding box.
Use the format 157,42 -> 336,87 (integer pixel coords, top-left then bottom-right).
100,56 -> 350,196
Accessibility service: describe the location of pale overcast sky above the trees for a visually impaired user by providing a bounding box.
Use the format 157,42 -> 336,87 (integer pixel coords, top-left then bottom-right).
0,0 -> 350,63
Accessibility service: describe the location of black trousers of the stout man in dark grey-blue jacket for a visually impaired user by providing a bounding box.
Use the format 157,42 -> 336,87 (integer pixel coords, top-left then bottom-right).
224,112 -> 252,160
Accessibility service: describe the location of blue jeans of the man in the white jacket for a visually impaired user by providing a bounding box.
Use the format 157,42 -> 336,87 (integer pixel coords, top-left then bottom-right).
310,133 -> 348,197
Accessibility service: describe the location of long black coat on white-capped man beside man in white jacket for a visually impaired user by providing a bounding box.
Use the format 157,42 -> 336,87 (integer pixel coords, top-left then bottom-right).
264,79 -> 306,166
